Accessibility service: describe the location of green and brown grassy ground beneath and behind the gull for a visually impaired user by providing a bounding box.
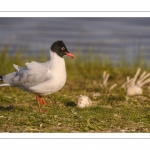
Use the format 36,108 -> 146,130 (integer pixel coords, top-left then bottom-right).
0,47 -> 150,133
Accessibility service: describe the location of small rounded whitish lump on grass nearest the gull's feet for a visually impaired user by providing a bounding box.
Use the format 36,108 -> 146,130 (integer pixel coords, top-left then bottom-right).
77,95 -> 92,108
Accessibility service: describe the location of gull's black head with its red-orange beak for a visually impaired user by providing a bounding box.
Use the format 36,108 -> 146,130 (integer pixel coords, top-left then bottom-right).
50,41 -> 74,58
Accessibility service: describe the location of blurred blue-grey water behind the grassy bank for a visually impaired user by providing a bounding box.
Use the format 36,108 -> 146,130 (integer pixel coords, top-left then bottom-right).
0,17 -> 150,62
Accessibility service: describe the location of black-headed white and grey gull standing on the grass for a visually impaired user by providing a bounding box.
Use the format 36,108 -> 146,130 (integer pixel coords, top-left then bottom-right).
0,41 -> 74,112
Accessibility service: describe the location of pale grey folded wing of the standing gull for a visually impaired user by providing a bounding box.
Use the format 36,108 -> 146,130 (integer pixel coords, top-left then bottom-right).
6,62 -> 51,90
